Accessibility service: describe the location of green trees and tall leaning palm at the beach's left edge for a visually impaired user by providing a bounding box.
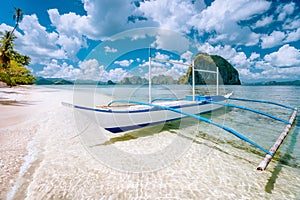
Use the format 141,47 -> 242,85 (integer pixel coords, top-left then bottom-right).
0,8 -> 35,86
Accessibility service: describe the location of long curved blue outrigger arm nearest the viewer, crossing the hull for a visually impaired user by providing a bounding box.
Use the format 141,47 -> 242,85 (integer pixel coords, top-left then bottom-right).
108,100 -> 273,156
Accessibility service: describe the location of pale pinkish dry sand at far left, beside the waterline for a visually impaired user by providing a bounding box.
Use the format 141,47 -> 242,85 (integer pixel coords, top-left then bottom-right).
0,86 -> 72,199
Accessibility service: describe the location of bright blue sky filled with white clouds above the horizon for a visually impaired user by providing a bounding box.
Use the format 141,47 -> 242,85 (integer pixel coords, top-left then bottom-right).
0,0 -> 300,82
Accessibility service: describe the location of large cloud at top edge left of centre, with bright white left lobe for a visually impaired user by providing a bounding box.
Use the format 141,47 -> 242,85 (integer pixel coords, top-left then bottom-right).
48,0 -> 154,43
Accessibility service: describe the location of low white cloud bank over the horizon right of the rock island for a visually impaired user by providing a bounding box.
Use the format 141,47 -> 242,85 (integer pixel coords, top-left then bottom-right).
199,43 -> 300,81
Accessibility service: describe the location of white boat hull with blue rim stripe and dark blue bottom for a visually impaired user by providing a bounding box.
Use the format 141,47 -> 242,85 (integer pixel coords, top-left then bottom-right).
71,96 -> 226,133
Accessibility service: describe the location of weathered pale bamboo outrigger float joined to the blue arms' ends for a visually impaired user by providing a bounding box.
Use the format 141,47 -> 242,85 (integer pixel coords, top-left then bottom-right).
257,108 -> 298,171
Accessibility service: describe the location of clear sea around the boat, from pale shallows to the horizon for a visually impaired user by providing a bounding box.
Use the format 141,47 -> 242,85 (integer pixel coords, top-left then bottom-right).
10,85 -> 300,199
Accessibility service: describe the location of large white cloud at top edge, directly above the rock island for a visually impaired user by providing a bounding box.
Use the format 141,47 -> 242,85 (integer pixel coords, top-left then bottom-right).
187,0 -> 271,45
